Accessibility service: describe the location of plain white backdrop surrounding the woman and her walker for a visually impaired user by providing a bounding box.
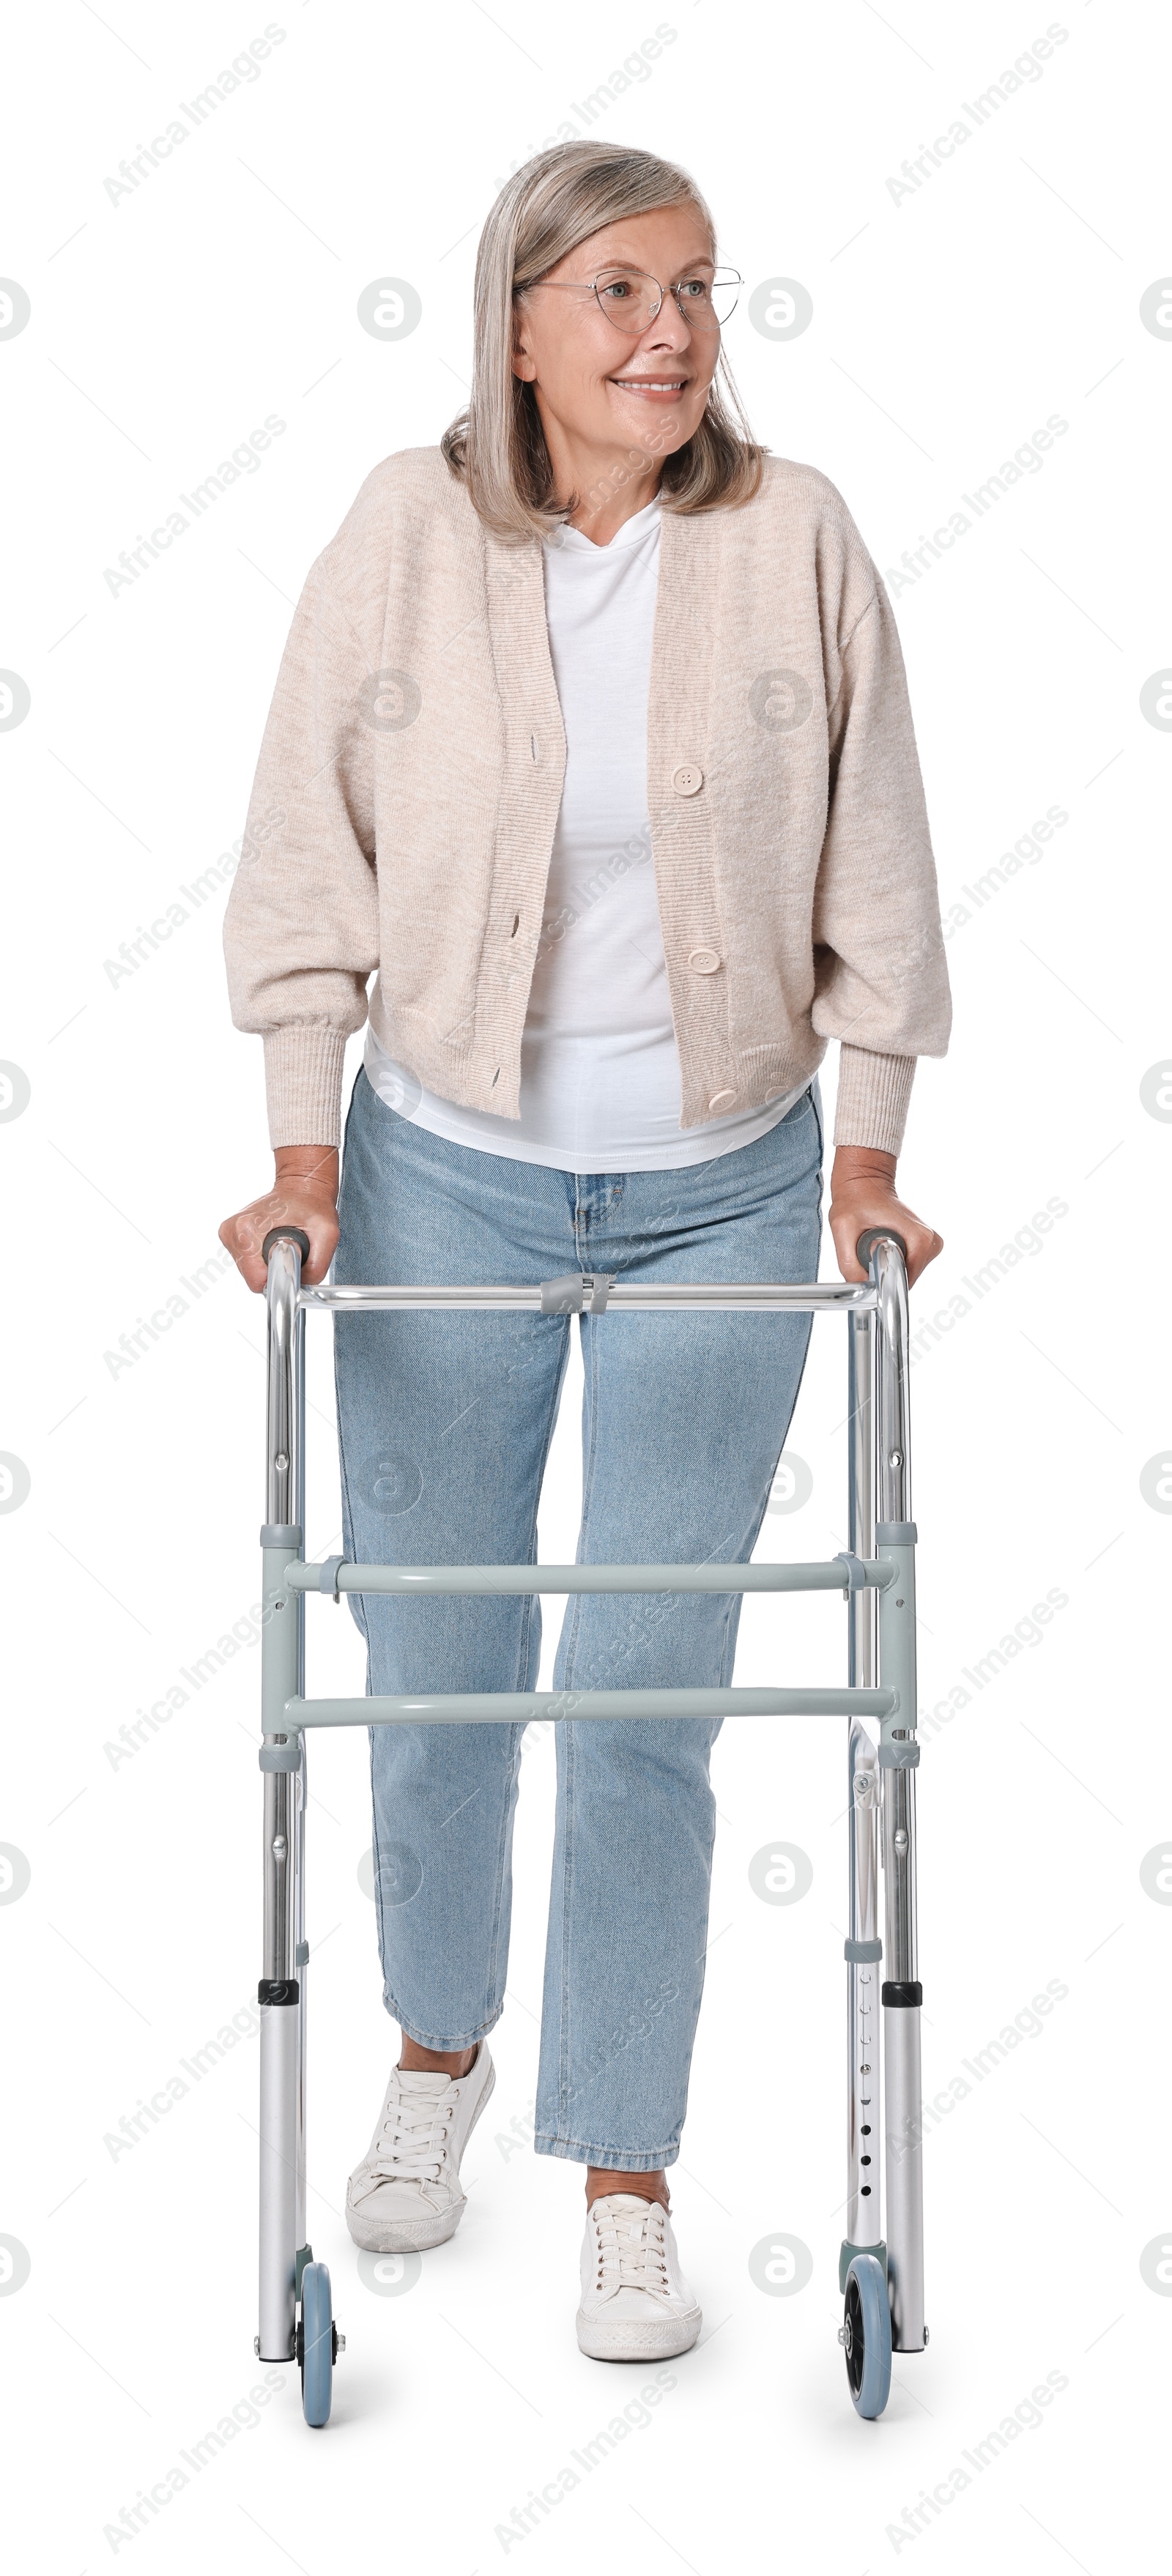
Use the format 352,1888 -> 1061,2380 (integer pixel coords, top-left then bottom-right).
0,0 -> 1172,2576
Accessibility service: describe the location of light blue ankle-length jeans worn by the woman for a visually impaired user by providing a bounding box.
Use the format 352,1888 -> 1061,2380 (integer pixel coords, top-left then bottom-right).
335,1074 -> 822,2172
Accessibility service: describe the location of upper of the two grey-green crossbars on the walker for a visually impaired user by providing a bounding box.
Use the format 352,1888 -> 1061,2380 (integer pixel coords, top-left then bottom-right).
286,1556 -> 891,1595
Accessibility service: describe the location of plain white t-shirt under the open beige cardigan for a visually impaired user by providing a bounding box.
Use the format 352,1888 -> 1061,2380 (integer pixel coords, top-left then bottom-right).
366,500 -> 806,1172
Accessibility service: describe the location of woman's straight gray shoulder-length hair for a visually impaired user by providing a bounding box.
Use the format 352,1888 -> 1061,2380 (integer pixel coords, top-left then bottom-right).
440,141 -> 765,541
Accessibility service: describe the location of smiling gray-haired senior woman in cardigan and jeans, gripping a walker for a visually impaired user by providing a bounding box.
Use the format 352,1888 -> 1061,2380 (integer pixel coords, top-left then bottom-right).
221,141 -> 948,2360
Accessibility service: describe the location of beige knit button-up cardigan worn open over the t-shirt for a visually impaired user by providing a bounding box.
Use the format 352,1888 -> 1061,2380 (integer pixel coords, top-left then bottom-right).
224,448 -> 951,1154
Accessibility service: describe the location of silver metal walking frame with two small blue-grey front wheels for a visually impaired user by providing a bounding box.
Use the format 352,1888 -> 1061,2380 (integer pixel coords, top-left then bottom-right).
255,1229 -> 927,2424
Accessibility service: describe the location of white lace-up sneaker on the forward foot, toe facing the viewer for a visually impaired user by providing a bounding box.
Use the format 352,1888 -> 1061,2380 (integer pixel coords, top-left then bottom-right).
577,2192 -> 703,2362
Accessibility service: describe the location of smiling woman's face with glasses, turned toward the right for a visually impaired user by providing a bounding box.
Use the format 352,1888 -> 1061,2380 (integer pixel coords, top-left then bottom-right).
513,206 -> 722,456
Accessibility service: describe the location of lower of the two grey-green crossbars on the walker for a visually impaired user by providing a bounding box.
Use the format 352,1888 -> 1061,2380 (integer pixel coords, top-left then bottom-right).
283,1690 -> 897,1734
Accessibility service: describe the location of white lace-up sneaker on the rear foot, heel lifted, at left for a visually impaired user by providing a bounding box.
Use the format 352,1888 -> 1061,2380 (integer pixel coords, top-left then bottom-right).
345,2040 -> 497,2254
